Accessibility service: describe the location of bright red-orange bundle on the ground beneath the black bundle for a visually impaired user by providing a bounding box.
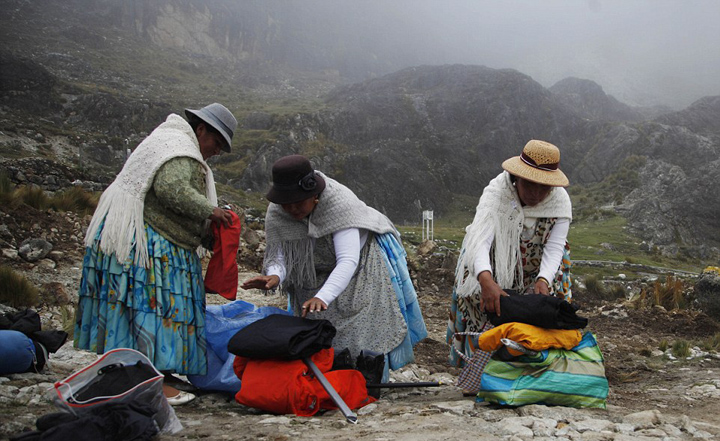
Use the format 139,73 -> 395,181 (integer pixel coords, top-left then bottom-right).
233,348 -> 375,416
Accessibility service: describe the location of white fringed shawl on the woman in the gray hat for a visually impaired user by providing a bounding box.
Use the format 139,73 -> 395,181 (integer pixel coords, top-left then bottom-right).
85,114 -> 217,268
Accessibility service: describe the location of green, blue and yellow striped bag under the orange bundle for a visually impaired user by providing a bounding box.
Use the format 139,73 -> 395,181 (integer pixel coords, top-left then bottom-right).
477,331 -> 608,409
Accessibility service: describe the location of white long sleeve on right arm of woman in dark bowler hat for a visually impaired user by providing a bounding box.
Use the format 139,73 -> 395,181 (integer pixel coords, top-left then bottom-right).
315,228 -> 368,306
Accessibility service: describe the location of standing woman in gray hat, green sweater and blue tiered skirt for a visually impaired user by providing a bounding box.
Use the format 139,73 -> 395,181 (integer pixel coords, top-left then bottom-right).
75,103 -> 237,404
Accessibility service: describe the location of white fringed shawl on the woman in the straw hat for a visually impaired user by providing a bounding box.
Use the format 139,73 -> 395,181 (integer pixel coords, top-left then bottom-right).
455,171 -> 572,297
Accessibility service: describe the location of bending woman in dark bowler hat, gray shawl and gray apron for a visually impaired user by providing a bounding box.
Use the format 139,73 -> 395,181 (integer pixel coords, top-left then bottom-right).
242,155 -> 427,378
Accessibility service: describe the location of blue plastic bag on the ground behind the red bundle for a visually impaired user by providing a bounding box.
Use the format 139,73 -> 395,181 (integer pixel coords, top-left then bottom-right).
187,300 -> 292,394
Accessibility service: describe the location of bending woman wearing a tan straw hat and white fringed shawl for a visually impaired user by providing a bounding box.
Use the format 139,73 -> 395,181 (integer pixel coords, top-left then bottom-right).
447,140 -> 572,366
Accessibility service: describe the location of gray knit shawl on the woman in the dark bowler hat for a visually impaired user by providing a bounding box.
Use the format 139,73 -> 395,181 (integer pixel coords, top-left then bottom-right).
263,171 -> 400,287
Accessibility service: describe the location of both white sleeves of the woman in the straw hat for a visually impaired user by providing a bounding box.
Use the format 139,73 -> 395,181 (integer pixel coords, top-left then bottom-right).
474,218 -> 570,283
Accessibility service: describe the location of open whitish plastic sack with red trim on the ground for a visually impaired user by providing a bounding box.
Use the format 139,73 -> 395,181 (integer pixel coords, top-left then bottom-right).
53,349 -> 182,434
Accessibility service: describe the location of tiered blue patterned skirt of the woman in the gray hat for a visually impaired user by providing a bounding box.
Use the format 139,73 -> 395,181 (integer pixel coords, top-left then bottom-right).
74,224 -> 207,375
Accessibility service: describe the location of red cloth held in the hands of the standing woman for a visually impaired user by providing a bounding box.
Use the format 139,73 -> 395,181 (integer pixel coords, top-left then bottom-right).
205,211 -> 241,300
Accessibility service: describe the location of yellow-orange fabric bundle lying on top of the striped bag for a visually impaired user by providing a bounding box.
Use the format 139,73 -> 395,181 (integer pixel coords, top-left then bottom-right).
478,322 -> 582,355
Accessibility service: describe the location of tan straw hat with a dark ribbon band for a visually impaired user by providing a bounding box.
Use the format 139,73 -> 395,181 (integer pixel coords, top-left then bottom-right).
502,139 -> 570,187
